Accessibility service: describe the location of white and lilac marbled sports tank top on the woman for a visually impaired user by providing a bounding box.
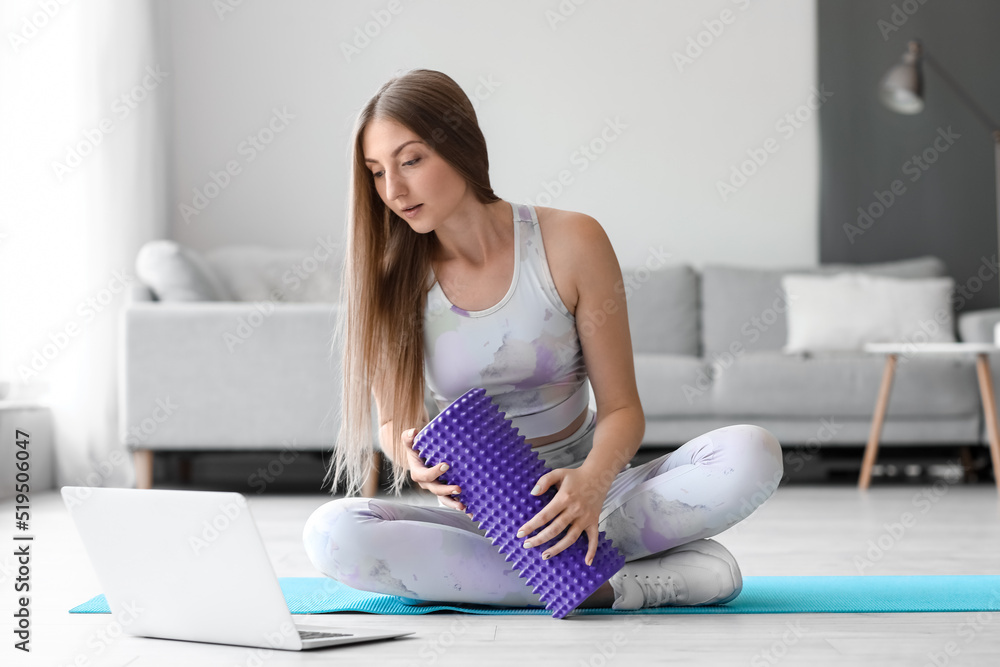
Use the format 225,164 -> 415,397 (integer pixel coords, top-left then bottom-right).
424,204 -> 590,439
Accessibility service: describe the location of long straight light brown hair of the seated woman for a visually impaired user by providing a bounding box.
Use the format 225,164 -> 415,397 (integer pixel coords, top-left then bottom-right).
324,69 -> 500,496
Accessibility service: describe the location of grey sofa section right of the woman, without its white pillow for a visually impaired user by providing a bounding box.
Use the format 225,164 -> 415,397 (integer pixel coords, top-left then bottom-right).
623,257 -> 1000,454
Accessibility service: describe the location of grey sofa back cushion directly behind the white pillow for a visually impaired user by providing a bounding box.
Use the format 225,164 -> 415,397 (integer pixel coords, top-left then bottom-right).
701,257 -> 946,355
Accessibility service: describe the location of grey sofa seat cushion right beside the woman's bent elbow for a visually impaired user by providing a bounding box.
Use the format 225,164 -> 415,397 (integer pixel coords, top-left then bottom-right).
635,354 -> 712,419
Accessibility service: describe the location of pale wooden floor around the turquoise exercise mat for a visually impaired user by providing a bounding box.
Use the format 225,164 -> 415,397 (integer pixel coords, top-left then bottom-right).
0,480 -> 1000,667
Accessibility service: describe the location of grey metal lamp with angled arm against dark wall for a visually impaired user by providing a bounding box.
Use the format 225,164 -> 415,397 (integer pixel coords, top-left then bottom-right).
879,40 -> 1000,320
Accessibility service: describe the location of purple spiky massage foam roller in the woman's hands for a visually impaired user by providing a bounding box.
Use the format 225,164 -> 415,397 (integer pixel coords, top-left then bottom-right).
413,388 -> 625,618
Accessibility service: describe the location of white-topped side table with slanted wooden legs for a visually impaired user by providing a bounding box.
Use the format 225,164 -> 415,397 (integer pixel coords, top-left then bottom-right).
858,343 -> 1000,493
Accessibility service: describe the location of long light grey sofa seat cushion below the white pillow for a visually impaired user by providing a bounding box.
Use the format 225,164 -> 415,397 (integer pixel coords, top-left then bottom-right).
712,351 -> 979,419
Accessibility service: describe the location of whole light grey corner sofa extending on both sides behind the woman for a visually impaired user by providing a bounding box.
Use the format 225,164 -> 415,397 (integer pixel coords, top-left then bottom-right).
120,245 -> 1000,490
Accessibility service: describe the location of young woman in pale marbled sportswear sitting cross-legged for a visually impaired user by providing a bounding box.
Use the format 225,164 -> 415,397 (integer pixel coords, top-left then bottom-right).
303,70 -> 782,609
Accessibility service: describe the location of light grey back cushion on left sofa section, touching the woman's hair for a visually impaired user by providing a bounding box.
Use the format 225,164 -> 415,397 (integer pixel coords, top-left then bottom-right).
205,245 -> 340,303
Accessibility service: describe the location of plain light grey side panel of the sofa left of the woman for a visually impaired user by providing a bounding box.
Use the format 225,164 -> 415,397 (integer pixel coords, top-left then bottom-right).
119,302 -> 340,450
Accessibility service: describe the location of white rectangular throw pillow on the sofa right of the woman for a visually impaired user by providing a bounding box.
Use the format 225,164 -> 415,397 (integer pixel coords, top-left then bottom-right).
781,272 -> 955,353
